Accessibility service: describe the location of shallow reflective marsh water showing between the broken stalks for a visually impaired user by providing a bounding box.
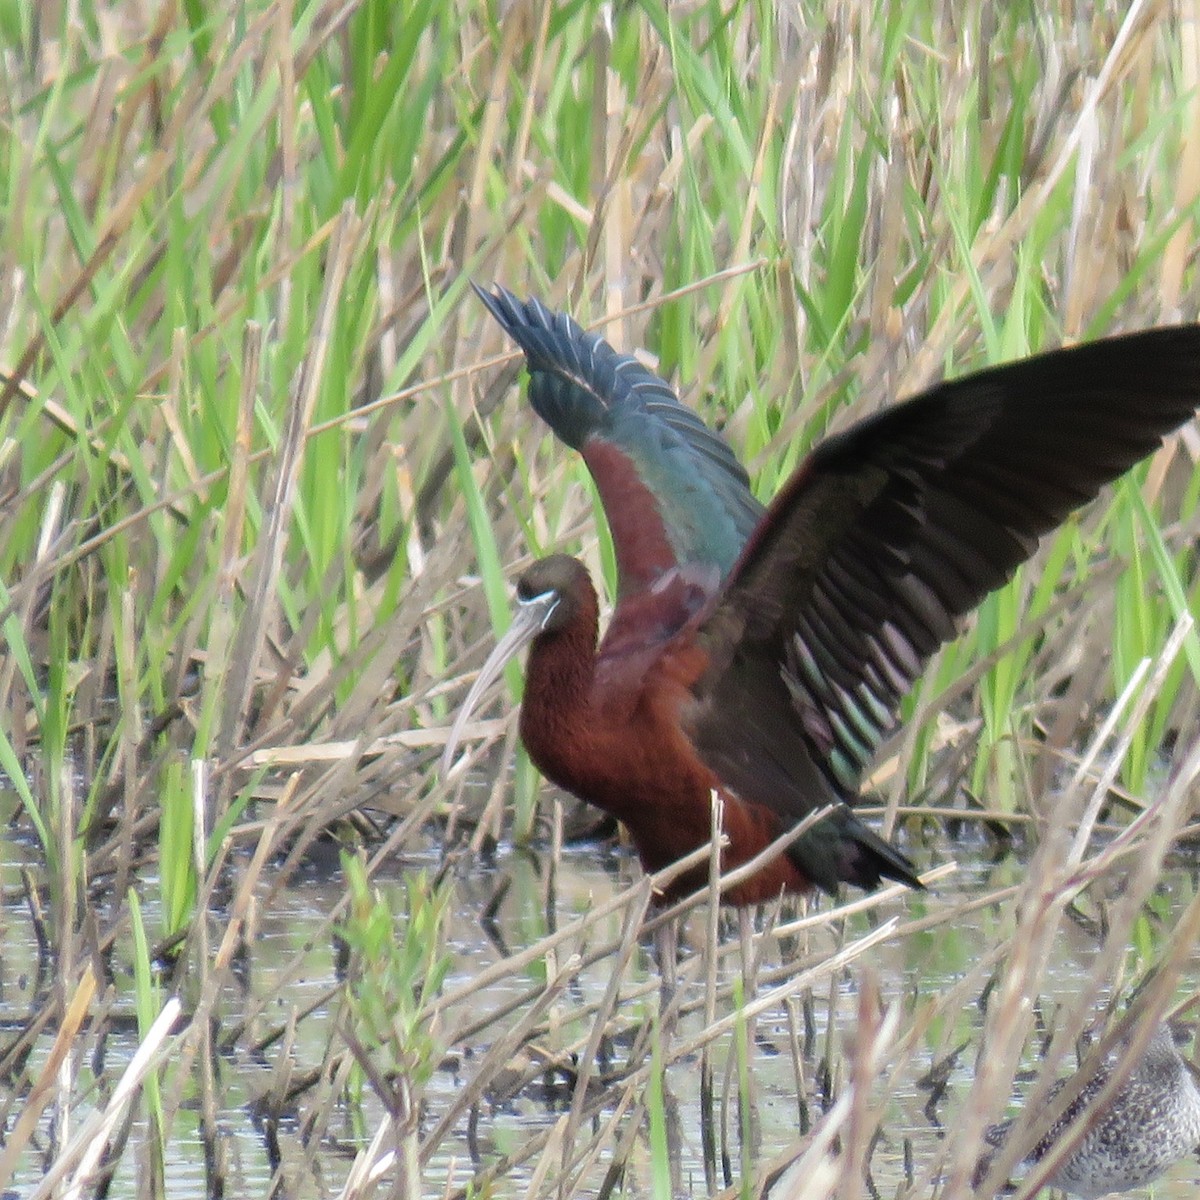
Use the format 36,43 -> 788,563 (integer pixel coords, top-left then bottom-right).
0,806 -> 1200,1198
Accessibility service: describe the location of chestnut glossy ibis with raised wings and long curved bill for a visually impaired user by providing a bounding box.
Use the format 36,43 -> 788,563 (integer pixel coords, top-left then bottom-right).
443,288 -> 1200,904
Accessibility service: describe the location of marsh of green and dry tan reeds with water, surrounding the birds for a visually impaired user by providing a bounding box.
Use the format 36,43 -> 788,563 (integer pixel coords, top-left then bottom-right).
0,0 -> 1200,1198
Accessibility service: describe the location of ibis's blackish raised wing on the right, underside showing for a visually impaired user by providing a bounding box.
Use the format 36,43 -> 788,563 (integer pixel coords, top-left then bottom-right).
690,325 -> 1200,873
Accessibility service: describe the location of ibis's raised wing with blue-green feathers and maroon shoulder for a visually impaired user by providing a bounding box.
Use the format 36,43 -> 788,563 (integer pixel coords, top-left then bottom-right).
473,284 -> 763,601
